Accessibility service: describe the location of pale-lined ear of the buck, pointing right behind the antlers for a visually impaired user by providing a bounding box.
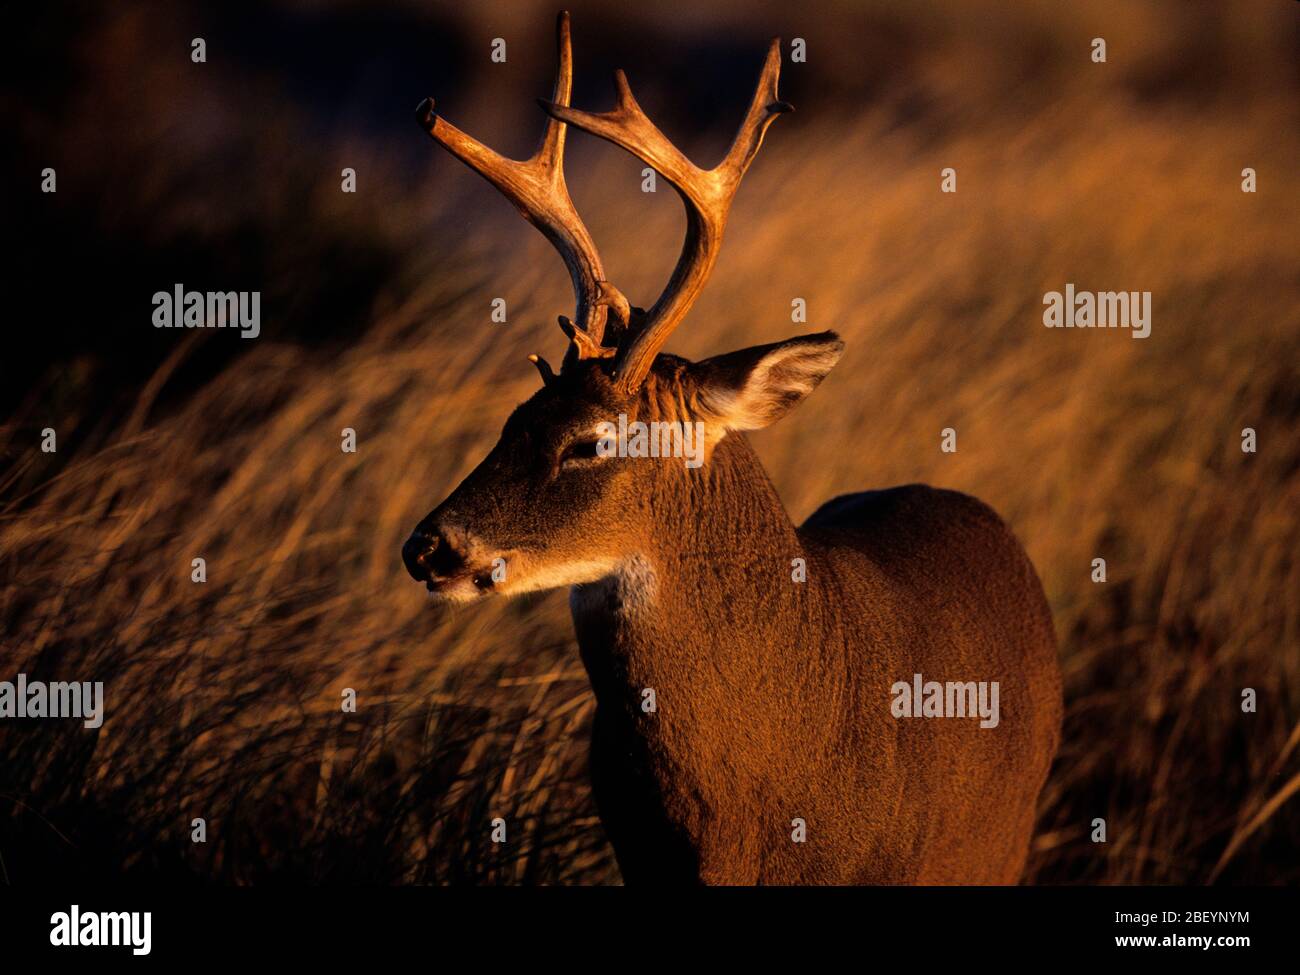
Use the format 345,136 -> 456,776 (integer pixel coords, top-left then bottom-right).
692,332 -> 844,430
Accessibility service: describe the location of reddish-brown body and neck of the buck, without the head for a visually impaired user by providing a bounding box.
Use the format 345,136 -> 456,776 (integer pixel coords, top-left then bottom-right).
571,418 -> 1061,884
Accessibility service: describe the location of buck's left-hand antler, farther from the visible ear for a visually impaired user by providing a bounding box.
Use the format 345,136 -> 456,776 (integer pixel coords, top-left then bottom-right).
416,10 -> 631,359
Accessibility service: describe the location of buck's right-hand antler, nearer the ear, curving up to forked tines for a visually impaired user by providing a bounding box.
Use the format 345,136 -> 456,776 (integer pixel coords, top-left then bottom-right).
542,38 -> 794,391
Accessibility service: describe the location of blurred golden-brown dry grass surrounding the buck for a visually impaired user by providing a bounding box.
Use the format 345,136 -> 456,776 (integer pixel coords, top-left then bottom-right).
0,5 -> 1300,883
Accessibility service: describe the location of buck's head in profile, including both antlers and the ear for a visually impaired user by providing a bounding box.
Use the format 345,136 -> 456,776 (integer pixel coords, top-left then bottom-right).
402,13 -> 842,602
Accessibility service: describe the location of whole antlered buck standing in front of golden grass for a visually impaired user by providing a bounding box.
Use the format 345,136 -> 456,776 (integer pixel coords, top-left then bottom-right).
402,14 -> 1062,884
